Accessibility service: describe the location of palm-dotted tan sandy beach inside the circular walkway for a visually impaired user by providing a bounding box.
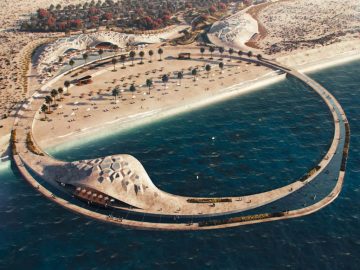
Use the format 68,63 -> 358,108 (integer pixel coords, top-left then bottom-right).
34,47 -> 273,150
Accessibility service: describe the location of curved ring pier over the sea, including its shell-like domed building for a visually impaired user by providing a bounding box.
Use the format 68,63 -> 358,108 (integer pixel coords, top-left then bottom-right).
12,51 -> 350,230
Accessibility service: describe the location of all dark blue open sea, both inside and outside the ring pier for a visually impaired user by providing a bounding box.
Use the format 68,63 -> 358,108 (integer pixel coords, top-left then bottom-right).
0,62 -> 360,269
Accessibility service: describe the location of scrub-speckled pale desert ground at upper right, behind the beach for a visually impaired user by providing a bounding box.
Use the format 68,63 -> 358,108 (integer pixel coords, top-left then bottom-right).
258,0 -> 360,53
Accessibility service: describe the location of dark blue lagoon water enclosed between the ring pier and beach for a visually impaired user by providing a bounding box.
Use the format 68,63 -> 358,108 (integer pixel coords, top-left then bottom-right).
50,75 -> 333,196
